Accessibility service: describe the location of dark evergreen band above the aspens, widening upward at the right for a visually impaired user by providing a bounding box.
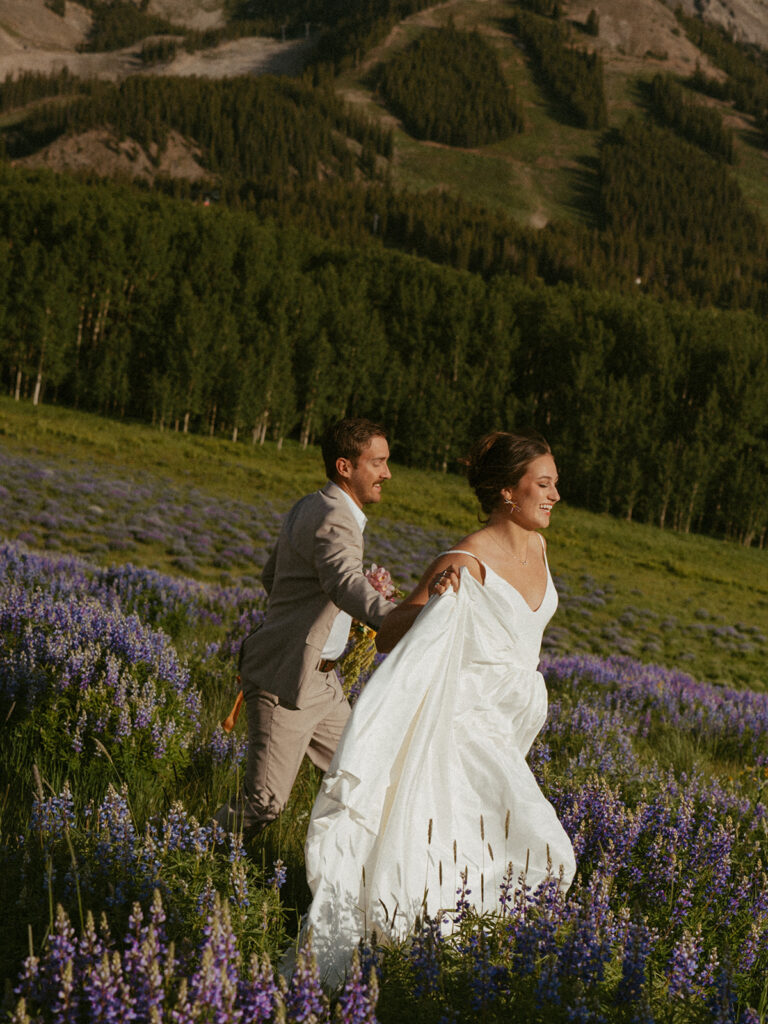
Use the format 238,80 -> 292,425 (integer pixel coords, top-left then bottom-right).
157,113 -> 768,314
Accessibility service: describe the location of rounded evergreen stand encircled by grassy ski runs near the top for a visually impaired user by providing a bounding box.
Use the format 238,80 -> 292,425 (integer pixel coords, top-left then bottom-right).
379,26 -> 522,146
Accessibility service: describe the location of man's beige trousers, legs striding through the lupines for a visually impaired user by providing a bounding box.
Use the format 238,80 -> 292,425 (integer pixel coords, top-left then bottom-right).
214,672 -> 350,831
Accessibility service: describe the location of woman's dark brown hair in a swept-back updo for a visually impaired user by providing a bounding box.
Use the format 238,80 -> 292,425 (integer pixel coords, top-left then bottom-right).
462,430 -> 552,515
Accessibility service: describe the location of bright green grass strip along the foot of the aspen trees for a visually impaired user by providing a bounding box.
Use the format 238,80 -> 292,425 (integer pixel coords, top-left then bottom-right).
0,397 -> 768,689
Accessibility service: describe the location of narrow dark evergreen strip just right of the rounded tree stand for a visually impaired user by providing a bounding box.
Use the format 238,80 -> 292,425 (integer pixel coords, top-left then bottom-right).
512,10 -> 608,128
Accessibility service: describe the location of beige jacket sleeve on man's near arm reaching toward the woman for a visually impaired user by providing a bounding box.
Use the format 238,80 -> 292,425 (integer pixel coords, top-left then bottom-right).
313,507 -> 393,630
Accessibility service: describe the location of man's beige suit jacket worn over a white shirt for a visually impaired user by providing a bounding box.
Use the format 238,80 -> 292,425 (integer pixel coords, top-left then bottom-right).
240,481 -> 392,708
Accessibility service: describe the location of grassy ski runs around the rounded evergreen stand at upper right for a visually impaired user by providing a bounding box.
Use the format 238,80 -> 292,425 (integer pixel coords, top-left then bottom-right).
337,0 -> 768,227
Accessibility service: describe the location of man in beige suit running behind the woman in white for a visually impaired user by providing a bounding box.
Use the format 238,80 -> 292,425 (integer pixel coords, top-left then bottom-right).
214,419 -> 392,833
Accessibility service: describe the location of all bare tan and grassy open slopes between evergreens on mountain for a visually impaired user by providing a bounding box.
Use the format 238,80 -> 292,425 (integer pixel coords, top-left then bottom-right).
0,0 -> 768,228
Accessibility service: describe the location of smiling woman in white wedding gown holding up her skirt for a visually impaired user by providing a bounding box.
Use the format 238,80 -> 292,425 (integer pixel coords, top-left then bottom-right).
303,431 -> 575,986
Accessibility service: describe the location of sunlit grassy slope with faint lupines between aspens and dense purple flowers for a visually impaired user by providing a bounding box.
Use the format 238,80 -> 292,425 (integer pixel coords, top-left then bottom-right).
0,398 -> 768,689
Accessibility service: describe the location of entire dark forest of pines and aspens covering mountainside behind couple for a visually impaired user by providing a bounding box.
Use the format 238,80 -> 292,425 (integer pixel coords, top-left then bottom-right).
0,0 -> 768,545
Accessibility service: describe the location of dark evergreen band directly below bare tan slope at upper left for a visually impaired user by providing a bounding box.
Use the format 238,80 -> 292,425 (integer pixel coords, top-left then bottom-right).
0,72 -> 392,180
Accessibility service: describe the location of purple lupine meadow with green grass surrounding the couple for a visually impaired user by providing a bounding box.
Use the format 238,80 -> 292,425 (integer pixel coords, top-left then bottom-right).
0,401 -> 768,1024
